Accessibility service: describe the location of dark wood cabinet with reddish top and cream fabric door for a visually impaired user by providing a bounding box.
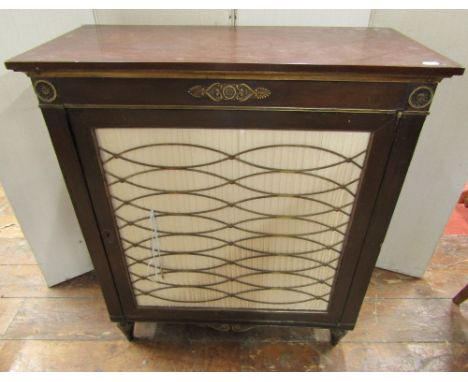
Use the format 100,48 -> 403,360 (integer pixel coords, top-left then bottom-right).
6,26 -> 463,343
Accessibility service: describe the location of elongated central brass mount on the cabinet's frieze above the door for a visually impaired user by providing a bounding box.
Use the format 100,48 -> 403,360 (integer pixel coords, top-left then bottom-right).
188,82 -> 271,102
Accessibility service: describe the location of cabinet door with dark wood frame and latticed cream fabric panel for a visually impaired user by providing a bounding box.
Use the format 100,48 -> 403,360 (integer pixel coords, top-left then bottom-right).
69,109 -> 395,324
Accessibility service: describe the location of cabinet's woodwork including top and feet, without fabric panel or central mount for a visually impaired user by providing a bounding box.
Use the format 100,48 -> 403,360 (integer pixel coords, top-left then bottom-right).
6,26 -> 464,343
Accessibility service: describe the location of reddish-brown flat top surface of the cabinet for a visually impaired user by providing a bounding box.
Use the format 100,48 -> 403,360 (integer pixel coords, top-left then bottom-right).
6,25 -> 463,77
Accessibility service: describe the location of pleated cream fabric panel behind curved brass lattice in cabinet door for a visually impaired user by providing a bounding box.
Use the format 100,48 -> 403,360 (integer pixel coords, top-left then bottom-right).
96,128 -> 369,311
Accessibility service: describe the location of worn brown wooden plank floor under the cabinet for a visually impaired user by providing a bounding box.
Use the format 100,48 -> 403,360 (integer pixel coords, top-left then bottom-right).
0,188 -> 468,371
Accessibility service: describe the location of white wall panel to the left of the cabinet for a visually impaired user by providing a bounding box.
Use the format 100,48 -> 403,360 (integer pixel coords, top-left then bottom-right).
0,10 -> 94,286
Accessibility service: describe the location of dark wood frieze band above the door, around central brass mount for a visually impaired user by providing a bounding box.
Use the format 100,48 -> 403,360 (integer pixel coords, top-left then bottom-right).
31,78 -> 414,110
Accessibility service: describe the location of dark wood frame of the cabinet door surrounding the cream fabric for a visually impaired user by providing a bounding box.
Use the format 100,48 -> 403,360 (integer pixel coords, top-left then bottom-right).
69,109 -> 396,324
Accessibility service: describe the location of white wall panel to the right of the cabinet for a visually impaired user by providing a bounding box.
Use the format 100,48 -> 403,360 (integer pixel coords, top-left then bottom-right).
371,10 -> 468,276
